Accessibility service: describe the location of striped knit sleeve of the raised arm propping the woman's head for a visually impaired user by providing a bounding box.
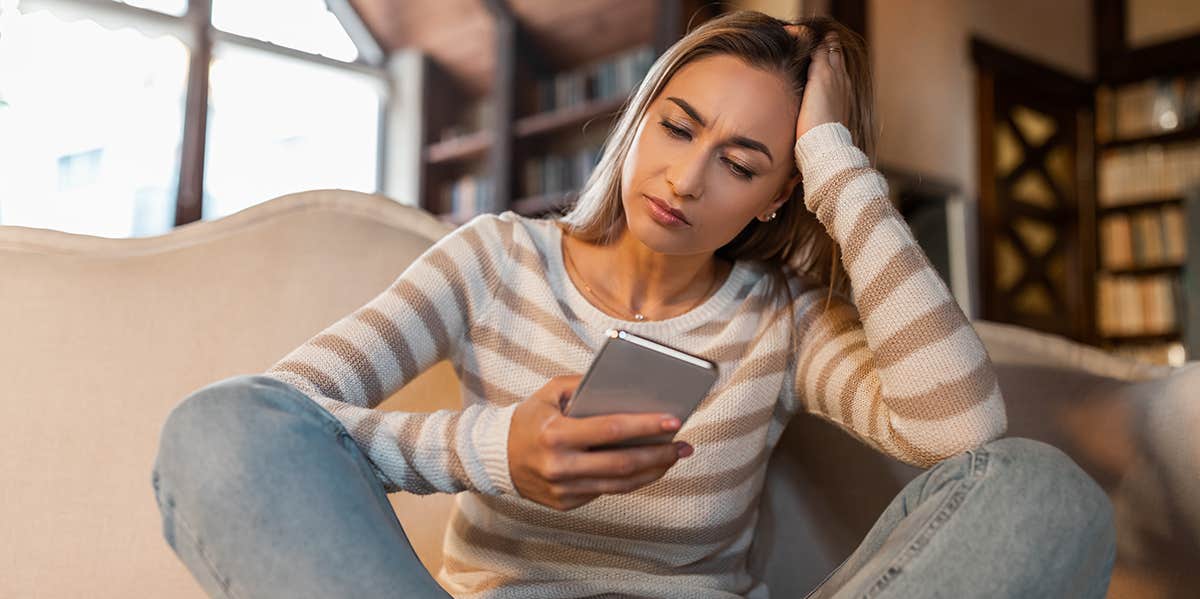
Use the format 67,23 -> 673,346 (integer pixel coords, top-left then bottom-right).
791,122 -> 1007,467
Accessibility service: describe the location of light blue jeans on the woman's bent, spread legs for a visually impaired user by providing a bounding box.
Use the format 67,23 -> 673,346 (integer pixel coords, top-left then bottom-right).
151,375 -> 1115,599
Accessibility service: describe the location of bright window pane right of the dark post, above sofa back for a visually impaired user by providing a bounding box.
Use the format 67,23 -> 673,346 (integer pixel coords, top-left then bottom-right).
203,44 -> 383,220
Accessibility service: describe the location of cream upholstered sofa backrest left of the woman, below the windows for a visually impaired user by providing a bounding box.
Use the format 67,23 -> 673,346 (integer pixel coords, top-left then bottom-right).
0,190 -> 458,598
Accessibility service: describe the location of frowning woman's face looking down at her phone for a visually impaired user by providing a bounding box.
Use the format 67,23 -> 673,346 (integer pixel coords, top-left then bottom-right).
620,55 -> 799,254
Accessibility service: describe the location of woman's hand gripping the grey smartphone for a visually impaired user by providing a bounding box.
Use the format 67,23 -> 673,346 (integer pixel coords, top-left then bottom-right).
508,375 -> 692,511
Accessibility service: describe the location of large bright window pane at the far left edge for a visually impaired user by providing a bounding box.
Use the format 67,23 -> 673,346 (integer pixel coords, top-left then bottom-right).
0,5 -> 188,238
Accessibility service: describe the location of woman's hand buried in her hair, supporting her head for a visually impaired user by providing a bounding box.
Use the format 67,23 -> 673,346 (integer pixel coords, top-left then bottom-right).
786,25 -> 852,139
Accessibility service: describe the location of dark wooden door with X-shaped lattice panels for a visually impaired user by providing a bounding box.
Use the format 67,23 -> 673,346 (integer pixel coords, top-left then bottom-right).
972,41 -> 1096,341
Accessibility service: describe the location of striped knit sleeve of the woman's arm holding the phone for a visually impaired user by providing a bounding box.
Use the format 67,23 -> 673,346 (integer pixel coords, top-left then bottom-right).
264,215 -> 516,495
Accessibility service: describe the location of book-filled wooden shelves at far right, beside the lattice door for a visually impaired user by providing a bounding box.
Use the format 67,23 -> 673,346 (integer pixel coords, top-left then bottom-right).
1094,72 -> 1200,364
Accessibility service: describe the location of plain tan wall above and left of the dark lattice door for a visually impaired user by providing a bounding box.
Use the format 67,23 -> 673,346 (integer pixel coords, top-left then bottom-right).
868,0 -> 1094,199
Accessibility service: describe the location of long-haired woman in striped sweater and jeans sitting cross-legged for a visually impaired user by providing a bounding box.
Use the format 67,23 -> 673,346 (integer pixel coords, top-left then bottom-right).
154,12 -> 1114,598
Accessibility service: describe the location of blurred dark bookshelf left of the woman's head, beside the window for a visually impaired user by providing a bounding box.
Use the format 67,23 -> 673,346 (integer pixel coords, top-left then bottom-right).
419,0 -> 722,224
